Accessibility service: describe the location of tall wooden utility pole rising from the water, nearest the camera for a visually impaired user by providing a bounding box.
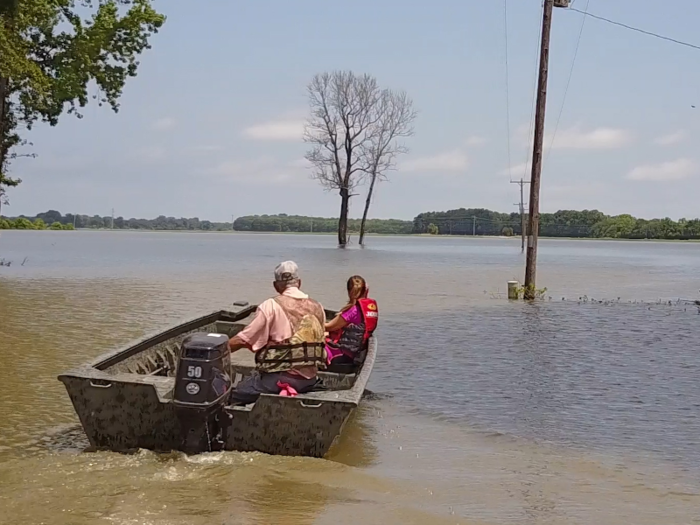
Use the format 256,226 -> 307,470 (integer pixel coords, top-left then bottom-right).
524,0 -> 569,299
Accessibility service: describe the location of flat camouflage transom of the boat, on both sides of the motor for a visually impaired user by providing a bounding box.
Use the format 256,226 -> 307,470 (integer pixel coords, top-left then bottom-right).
57,376 -> 357,457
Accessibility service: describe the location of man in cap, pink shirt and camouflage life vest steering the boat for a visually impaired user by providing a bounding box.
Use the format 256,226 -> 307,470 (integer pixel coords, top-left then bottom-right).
229,261 -> 328,404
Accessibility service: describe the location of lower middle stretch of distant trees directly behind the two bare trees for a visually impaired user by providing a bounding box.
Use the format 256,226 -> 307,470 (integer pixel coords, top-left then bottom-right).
233,213 -> 413,235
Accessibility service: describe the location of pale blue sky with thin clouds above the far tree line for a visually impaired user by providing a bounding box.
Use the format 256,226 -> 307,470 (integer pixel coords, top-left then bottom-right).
3,0 -> 700,221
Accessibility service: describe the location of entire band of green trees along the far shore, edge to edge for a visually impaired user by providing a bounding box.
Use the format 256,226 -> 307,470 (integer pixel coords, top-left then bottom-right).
0,208 -> 700,240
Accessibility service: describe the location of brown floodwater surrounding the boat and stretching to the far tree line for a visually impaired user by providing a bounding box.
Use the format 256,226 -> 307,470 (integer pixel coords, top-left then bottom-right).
0,232 -> 700,525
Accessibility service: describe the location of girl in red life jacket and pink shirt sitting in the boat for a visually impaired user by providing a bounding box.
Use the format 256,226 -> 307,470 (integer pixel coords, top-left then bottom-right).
326,275 -> 379,372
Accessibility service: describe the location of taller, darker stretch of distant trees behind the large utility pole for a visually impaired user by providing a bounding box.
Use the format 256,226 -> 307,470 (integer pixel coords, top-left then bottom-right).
411,208 -> 700,240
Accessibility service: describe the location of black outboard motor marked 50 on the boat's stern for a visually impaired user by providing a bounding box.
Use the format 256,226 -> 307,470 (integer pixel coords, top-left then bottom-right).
173,332 -> 231,454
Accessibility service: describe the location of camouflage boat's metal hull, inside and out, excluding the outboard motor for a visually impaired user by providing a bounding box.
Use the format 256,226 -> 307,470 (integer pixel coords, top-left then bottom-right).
59,304 -> 377,457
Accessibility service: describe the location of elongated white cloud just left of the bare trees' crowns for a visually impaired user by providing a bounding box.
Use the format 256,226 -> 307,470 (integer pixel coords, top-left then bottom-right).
198,157 -> 308,185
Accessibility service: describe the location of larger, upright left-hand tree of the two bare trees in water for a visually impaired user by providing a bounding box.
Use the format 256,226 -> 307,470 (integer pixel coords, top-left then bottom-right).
304,71 -> 382,246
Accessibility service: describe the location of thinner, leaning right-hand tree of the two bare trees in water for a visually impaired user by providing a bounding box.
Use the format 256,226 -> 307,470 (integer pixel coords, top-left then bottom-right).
360,89 -> 416,244
